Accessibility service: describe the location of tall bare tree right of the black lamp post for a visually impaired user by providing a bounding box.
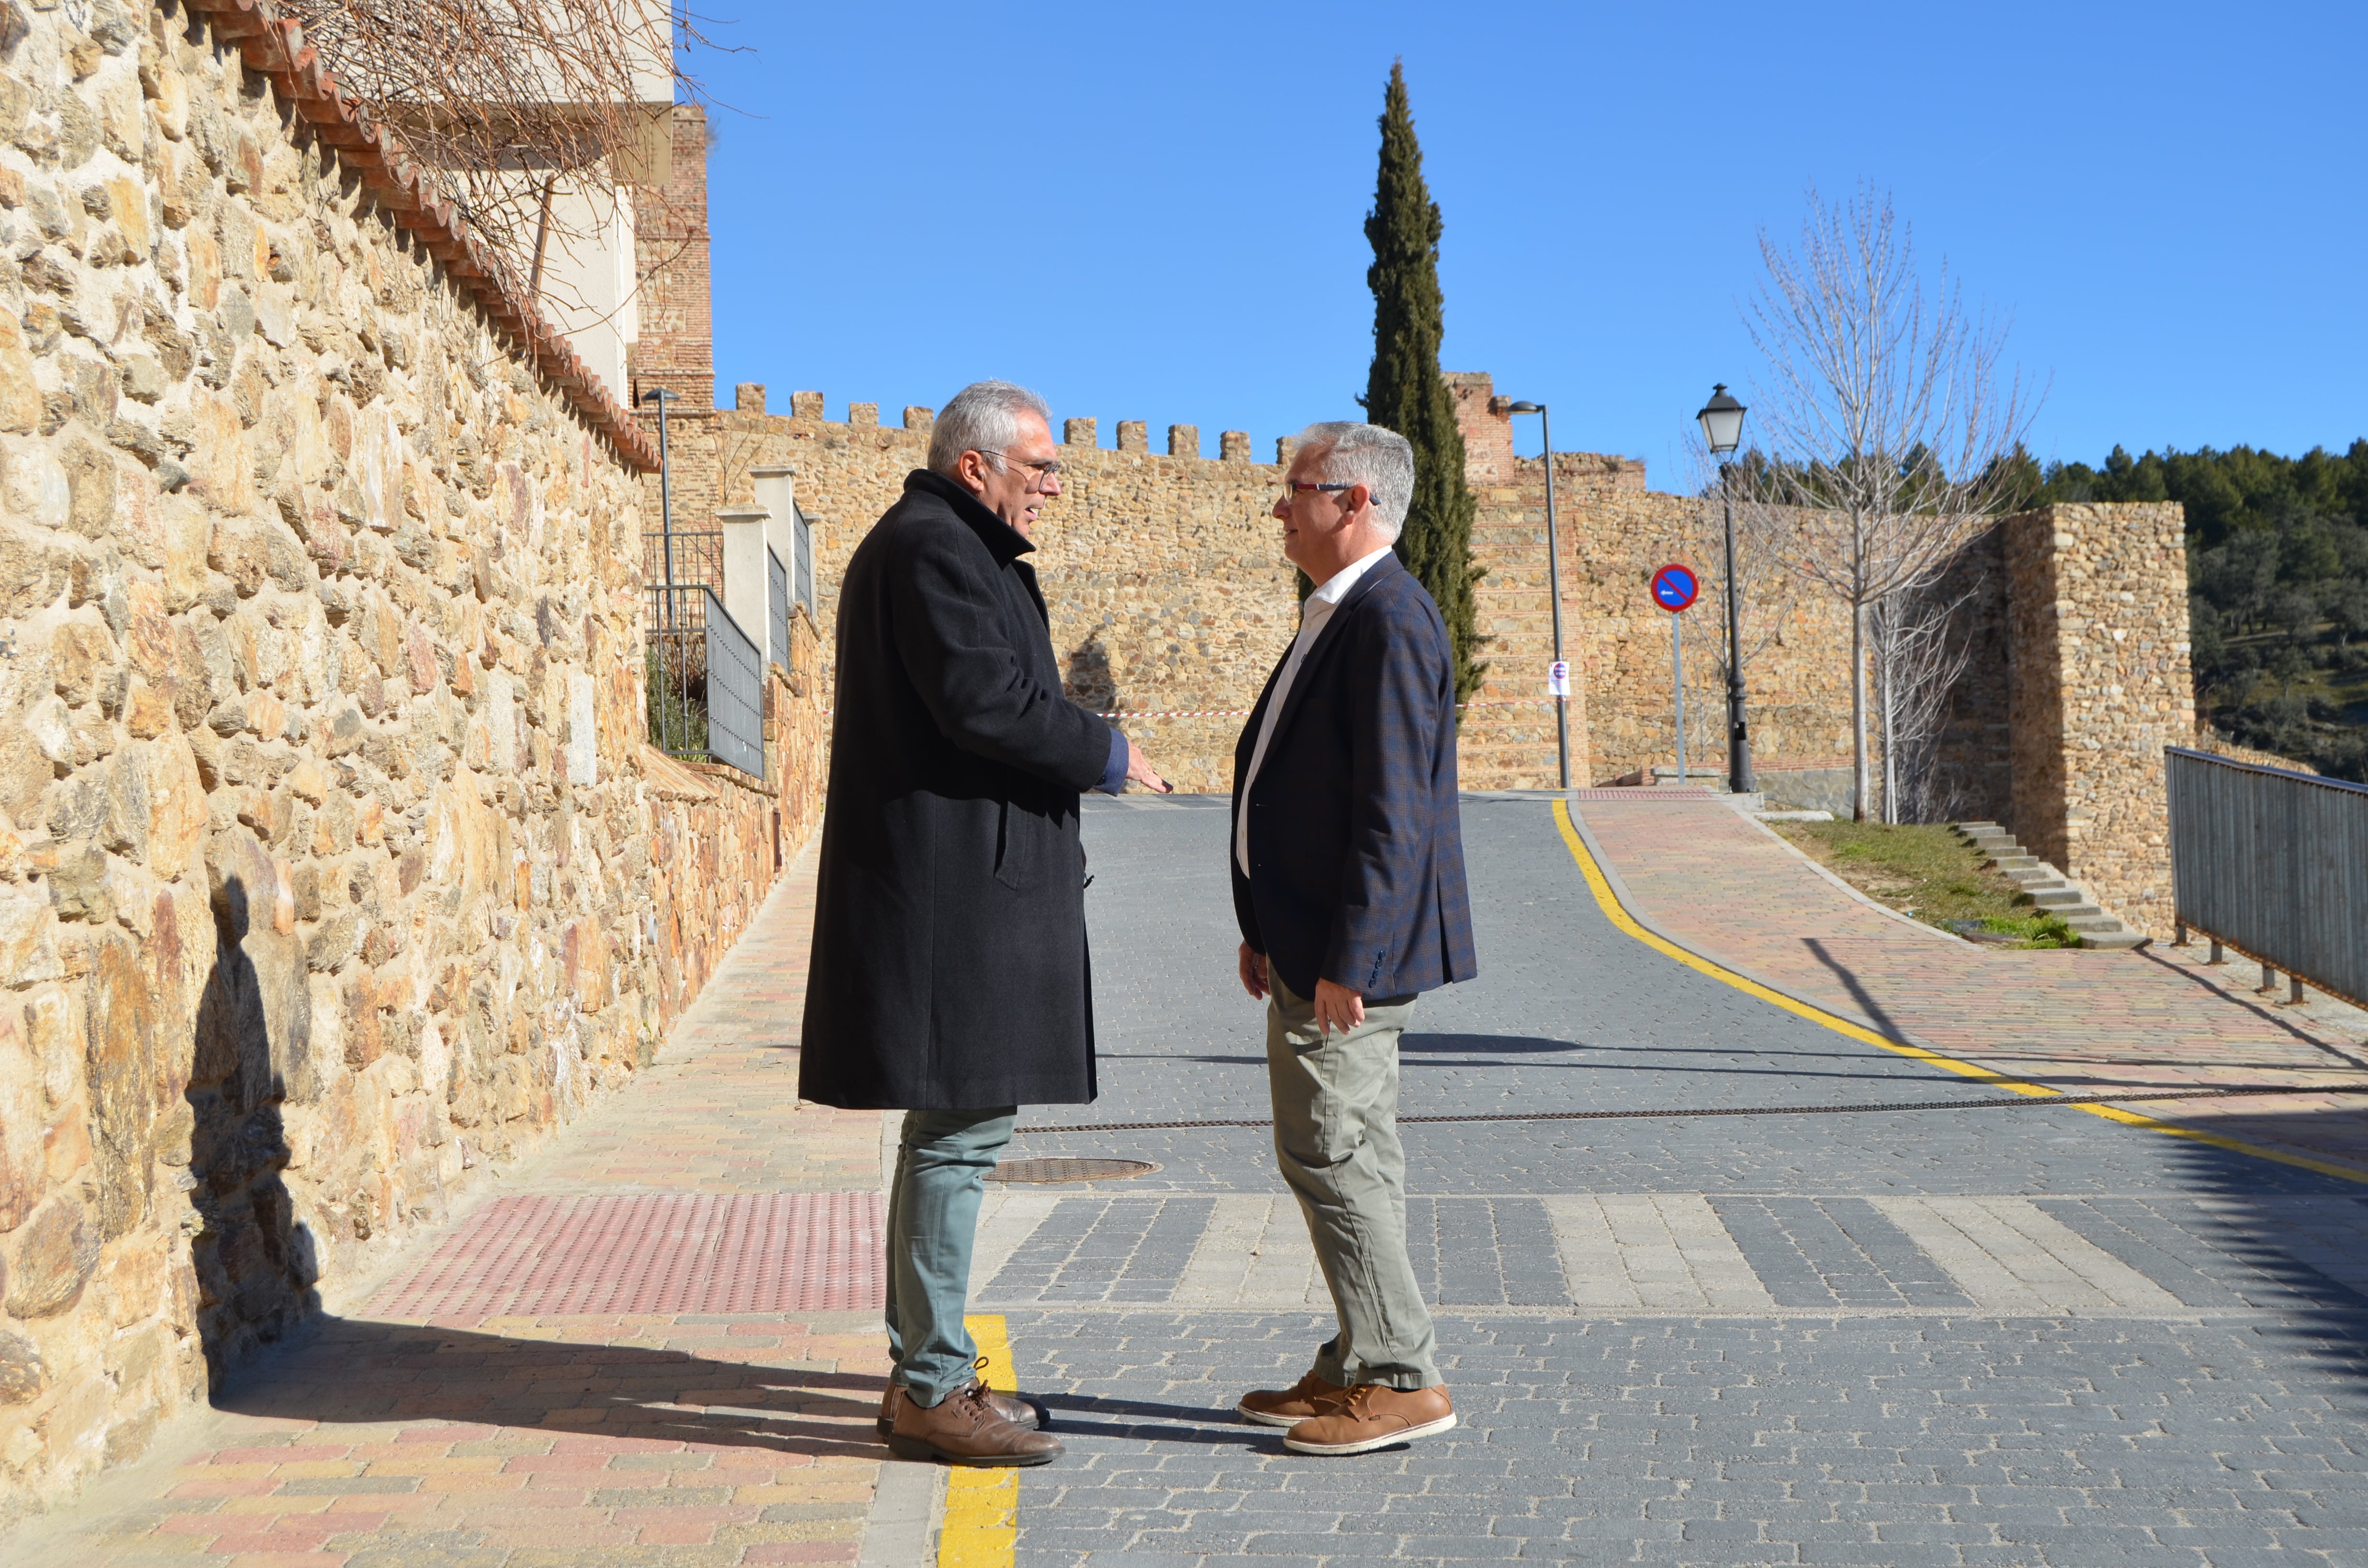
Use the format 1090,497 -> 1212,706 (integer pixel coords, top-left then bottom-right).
1745,185 -> 2032,822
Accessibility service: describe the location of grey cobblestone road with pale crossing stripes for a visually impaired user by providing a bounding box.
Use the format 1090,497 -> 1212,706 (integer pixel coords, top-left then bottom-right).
973,798 -> 2368,1568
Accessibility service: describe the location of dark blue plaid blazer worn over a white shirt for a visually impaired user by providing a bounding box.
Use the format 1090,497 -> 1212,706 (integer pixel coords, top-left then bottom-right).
1224,554 -> 1480,1000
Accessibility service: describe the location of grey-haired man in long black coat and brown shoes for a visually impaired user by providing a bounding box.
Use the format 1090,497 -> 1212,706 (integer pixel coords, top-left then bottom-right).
798,381 -> 1168,1464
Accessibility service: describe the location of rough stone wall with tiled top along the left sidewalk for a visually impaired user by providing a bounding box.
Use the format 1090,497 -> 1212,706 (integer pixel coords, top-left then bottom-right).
0,5 -> 822,1518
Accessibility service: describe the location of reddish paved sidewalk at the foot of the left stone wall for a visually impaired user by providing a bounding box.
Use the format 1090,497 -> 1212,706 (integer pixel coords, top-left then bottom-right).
12,858 -> 883,1568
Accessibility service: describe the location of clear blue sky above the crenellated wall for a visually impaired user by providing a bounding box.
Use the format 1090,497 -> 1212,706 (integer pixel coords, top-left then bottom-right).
691,0 -> 2368,488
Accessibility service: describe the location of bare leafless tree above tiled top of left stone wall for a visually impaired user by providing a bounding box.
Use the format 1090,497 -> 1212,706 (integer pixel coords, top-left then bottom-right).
280,0 -> 706,324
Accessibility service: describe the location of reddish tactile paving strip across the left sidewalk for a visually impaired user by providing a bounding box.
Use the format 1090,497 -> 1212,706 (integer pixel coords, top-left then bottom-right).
370,1191 -> 886,1322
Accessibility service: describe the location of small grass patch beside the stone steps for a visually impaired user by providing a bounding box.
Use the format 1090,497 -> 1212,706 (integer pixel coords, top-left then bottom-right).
1769,822 -> 2079,947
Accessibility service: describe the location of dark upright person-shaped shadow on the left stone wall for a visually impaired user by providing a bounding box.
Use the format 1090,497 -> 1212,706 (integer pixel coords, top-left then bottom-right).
187,871 -> 320,1385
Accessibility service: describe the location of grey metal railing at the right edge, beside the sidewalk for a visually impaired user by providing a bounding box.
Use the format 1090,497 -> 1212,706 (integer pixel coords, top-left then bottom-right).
2164,746 -> 2368,1002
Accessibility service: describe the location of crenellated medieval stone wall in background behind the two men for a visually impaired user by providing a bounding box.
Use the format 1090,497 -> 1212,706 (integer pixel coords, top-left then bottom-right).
691,393 -> 1885,791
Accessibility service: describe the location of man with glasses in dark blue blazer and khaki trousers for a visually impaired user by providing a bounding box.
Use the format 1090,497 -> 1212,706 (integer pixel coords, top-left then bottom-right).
1232,422 -> 1478,1454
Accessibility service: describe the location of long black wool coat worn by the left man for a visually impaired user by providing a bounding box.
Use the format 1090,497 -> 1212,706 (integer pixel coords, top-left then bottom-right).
798,469 -> 1110,1111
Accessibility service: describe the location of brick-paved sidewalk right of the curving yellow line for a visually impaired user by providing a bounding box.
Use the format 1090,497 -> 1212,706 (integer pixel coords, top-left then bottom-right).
1570,791 -> 2368,1179
